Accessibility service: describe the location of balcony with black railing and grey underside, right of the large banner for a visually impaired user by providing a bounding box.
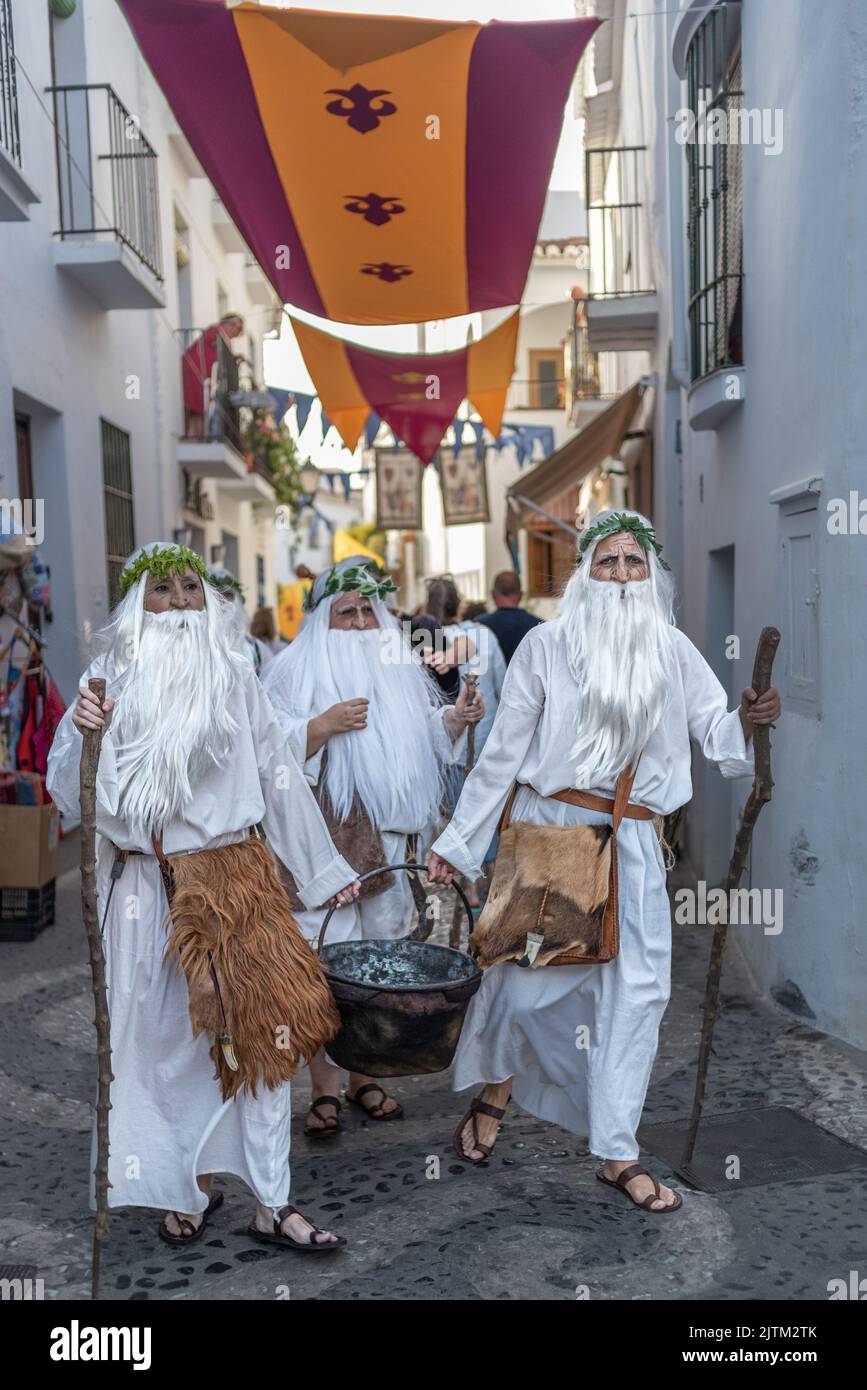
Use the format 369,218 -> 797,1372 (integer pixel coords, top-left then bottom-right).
585,145 -> 659,353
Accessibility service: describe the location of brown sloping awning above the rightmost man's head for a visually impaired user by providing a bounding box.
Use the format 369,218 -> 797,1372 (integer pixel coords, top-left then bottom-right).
506,381 -> 643,534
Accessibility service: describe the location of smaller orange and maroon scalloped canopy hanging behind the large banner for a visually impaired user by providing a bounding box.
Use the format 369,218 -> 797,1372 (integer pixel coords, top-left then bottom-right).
292,311 -> 518,463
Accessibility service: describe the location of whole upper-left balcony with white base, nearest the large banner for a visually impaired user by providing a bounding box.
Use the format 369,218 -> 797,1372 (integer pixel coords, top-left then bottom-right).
47,83 -> 165,309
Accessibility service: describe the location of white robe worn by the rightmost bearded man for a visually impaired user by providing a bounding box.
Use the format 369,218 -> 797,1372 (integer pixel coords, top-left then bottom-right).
434,621 -> 753,1162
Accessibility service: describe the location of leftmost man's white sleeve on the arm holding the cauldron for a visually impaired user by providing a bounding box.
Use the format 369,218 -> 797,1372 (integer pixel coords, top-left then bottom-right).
245,671 -> 357,908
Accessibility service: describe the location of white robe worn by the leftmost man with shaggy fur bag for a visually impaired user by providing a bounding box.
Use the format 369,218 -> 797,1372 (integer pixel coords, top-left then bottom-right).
47,664 -> 354,1212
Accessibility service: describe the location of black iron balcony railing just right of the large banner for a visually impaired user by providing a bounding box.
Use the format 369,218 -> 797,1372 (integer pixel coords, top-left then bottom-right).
585,145 -> 654,299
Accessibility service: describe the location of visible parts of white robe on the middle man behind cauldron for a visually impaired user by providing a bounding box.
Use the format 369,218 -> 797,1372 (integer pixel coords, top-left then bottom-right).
275,705 -> 467,942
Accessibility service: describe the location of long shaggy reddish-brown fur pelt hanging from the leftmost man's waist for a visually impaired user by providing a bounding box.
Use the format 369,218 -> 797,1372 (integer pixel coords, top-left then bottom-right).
165,837 -> 340,1099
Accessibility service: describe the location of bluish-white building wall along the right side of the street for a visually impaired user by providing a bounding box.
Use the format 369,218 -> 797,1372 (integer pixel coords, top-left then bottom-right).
589,0 -> 867,1047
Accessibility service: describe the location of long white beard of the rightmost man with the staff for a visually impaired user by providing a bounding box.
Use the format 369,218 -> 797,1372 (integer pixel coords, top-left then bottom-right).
560,575 -> 672,790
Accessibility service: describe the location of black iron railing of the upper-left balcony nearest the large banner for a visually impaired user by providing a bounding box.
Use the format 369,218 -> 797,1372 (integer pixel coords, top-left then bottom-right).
46,82 -> 163,279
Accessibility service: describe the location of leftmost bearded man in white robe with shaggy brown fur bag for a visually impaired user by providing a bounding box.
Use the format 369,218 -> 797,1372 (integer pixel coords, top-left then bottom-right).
47,542 -> 357,1251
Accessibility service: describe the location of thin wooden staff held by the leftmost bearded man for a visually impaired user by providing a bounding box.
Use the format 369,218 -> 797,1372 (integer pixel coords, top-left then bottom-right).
79,677 -> 114,1298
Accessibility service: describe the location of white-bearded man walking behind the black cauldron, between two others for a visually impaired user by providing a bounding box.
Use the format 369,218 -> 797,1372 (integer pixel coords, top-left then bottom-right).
263,556 -> 485,1136
